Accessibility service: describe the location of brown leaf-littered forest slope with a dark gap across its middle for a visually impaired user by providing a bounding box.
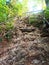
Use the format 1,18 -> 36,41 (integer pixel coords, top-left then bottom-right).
0,17 -> 49,65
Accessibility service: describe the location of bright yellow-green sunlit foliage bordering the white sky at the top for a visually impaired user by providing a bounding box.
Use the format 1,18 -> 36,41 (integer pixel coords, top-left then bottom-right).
9,0 -> 28,16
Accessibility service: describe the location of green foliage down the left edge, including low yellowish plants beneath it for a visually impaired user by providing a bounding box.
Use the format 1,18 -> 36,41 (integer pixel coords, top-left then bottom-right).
0,0 -> 14,32
